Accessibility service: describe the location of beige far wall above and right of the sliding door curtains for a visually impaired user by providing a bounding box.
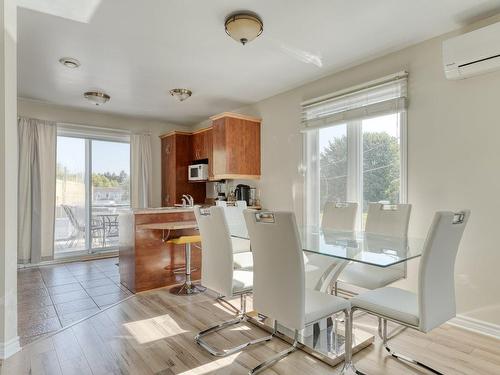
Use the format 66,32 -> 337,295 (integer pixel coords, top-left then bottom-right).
17,99 -> 184,207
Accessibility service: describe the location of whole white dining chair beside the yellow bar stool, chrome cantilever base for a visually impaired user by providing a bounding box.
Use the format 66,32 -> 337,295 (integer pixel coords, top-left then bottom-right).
194,207 -> 271,357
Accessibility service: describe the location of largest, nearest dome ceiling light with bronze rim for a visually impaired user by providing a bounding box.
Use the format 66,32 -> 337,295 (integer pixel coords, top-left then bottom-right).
224,11 -> 264,45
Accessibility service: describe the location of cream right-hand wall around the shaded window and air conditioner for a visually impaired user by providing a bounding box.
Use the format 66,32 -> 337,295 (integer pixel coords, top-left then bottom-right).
196,16 -> 500,325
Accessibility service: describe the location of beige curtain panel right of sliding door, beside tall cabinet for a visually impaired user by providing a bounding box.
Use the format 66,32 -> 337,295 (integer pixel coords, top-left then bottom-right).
130,134 -> 153,208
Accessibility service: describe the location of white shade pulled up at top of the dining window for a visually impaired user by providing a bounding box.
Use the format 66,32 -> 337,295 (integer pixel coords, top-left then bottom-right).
302,72 -> 408,131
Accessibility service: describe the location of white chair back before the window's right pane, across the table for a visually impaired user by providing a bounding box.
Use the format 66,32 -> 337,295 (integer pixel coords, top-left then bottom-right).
365,203 -> 411,237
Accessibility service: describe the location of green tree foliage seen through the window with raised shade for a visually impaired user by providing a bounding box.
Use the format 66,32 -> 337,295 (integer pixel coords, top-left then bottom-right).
320,132 -> 400,207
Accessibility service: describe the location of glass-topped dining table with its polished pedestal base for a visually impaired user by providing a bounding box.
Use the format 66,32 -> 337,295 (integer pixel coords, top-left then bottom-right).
228,223 -> 425,366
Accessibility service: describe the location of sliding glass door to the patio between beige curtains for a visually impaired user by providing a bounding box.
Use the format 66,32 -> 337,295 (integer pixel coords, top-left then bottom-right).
54,132 -> 130,256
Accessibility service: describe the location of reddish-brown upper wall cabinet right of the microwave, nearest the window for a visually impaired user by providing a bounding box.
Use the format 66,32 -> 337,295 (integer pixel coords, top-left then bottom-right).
211,112 -> 261,180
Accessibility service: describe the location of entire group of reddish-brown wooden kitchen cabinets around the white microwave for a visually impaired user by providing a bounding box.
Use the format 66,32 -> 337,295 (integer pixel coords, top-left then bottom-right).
160,112 -> 261,206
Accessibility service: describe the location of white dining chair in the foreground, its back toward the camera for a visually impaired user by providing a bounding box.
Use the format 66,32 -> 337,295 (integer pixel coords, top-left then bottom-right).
244,210 -> 351,374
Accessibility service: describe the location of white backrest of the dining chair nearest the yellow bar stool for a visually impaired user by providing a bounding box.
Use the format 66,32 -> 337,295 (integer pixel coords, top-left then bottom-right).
194,207 -> 233,297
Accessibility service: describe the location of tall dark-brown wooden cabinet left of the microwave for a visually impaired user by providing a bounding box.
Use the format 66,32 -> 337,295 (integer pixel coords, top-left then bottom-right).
161,132 -> 206,206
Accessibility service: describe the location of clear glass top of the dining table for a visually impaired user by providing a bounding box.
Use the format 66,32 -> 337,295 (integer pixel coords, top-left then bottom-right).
229,225 -> 425,267
